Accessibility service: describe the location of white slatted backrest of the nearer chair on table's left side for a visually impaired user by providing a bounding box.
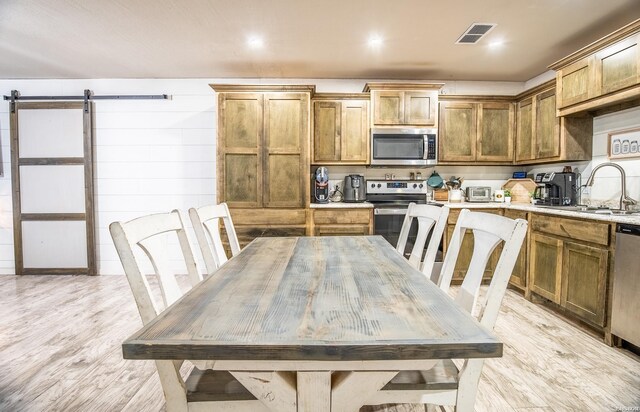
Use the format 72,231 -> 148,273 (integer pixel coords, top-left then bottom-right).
109,210 -> 202,325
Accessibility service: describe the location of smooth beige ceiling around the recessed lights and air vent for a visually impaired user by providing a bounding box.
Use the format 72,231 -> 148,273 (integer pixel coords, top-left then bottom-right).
0,0 -> 640,82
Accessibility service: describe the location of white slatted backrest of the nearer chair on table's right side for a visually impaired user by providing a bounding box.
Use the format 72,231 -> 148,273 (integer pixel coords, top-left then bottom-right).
438,209 -> 527,329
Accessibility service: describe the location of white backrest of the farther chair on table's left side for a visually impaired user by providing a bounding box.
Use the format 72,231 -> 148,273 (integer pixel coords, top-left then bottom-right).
189,203 -> 240,274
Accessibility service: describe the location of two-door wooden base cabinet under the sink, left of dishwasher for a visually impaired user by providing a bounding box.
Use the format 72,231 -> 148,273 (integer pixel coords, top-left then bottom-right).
529,214 -> 613,327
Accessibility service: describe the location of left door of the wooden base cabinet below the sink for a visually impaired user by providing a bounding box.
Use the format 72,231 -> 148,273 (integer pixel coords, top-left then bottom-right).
529,232 -> 562,303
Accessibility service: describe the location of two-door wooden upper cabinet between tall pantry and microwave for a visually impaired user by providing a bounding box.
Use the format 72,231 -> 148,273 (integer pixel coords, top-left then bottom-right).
312,94 -> 369,164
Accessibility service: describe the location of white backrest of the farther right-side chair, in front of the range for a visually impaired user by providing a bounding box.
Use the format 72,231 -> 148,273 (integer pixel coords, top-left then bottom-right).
396,203 -> 449,276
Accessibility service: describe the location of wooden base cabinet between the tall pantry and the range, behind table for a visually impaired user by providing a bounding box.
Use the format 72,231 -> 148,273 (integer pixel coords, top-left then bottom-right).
309,208 -> 373,236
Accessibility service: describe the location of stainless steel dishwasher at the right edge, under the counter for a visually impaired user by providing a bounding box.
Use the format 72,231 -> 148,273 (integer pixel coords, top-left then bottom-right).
611,223 -> 640,346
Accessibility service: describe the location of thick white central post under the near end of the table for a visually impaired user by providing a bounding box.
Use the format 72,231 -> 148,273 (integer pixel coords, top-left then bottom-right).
297,371 -> 331,412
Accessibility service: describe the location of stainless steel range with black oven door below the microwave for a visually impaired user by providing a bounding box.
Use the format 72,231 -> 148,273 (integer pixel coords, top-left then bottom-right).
367,180 -> 438,256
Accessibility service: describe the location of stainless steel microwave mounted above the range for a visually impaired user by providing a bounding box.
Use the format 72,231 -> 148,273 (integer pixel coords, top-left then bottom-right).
371,127 -> 438,166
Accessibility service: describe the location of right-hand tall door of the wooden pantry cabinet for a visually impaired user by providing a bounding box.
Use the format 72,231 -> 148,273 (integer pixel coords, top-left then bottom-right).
262,93 -> 309,207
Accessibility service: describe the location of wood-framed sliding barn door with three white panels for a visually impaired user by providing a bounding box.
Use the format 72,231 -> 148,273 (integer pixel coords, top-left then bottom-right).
11,102 -> 96,275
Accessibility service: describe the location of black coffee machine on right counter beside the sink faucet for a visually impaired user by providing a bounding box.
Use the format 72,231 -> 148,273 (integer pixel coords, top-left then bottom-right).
533,172 -> 578,206
